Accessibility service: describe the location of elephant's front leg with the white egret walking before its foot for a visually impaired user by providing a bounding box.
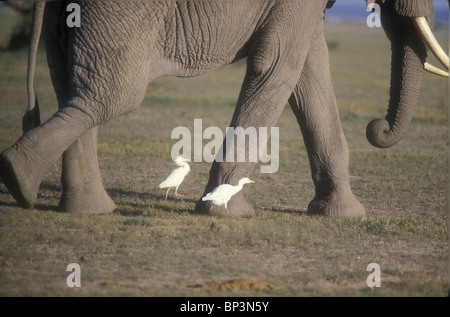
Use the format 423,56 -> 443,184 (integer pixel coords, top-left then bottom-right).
196,29 -> 306,217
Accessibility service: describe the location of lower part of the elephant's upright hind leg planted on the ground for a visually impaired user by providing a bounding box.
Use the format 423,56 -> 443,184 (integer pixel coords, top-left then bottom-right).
60,127 -> 116,213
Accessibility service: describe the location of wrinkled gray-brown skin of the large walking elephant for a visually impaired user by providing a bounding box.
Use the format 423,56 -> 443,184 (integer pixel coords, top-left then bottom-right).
0,0 -> 433,217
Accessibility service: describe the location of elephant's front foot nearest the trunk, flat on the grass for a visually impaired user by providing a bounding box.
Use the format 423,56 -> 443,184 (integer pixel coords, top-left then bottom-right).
308,190 -> 366,218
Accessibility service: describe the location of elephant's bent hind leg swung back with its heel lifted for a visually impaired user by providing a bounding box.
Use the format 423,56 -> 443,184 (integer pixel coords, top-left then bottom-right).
0,100 -> 95,208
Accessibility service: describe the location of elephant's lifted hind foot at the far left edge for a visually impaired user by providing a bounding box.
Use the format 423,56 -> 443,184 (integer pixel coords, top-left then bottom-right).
0,147 -> 41,208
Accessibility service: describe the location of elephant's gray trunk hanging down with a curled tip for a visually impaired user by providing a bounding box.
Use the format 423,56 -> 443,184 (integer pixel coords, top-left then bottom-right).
366,15 -> 426,148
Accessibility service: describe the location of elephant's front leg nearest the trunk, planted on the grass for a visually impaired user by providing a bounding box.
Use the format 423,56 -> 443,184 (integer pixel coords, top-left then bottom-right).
289,33 -> 365,217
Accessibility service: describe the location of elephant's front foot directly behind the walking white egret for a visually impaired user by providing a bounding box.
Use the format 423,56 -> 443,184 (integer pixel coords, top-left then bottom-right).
195,193 -> 255,218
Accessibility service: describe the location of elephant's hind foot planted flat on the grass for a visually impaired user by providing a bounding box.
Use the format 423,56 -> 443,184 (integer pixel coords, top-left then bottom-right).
59,186 -> 117,214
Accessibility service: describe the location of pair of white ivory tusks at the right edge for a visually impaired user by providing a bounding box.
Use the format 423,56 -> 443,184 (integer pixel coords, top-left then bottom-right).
413,17 -> 449,77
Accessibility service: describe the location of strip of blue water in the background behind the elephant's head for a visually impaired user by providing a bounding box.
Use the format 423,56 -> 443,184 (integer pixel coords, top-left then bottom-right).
325,0 -> 449,27
